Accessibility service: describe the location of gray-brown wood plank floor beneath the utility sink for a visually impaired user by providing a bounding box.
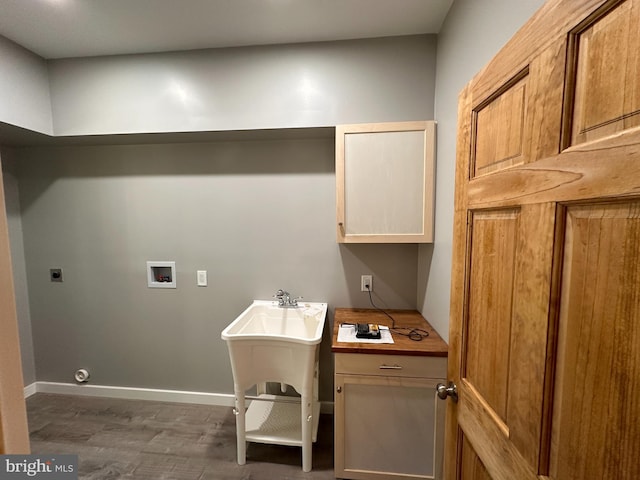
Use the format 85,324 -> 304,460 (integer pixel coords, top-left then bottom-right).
27,393 -> 335,480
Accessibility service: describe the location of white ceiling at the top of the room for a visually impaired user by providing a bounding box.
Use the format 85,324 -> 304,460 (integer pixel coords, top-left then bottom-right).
0,0 -> 453,59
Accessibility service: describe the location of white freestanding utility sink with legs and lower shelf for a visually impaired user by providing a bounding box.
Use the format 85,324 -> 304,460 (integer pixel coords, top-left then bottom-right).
221,300 -> 327,472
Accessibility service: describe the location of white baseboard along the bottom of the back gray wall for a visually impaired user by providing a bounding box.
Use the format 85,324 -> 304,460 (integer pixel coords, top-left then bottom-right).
24,382 -> 333,414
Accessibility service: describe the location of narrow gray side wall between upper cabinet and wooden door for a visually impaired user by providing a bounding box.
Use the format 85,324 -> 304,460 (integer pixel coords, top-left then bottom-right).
418,0 -> 544,340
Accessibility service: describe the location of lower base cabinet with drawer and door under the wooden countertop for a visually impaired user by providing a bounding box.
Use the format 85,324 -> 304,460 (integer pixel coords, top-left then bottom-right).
334,354 -> 447,480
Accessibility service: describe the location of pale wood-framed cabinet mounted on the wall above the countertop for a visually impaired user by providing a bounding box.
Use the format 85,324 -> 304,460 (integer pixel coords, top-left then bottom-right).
336,121 -> 435,243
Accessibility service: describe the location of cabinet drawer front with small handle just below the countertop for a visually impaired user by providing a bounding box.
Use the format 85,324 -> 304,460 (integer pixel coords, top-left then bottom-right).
335,353 -> 447,378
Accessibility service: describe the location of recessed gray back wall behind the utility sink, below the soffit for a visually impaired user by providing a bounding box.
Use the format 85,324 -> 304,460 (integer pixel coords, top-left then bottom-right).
3,138 -> 417,400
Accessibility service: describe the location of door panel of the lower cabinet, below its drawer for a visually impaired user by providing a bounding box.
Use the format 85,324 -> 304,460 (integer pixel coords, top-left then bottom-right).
335,375 -> 444,479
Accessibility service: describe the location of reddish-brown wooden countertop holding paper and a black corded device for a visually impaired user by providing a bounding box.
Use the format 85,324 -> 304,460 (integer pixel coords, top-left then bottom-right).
331,308 -> 449,357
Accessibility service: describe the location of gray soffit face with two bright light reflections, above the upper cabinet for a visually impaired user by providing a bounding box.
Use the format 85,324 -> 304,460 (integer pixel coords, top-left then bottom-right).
49,35 -> 436,135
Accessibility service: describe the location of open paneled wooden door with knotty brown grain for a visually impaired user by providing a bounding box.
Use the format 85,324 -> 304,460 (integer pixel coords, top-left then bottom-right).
445,0 -> 640,480
